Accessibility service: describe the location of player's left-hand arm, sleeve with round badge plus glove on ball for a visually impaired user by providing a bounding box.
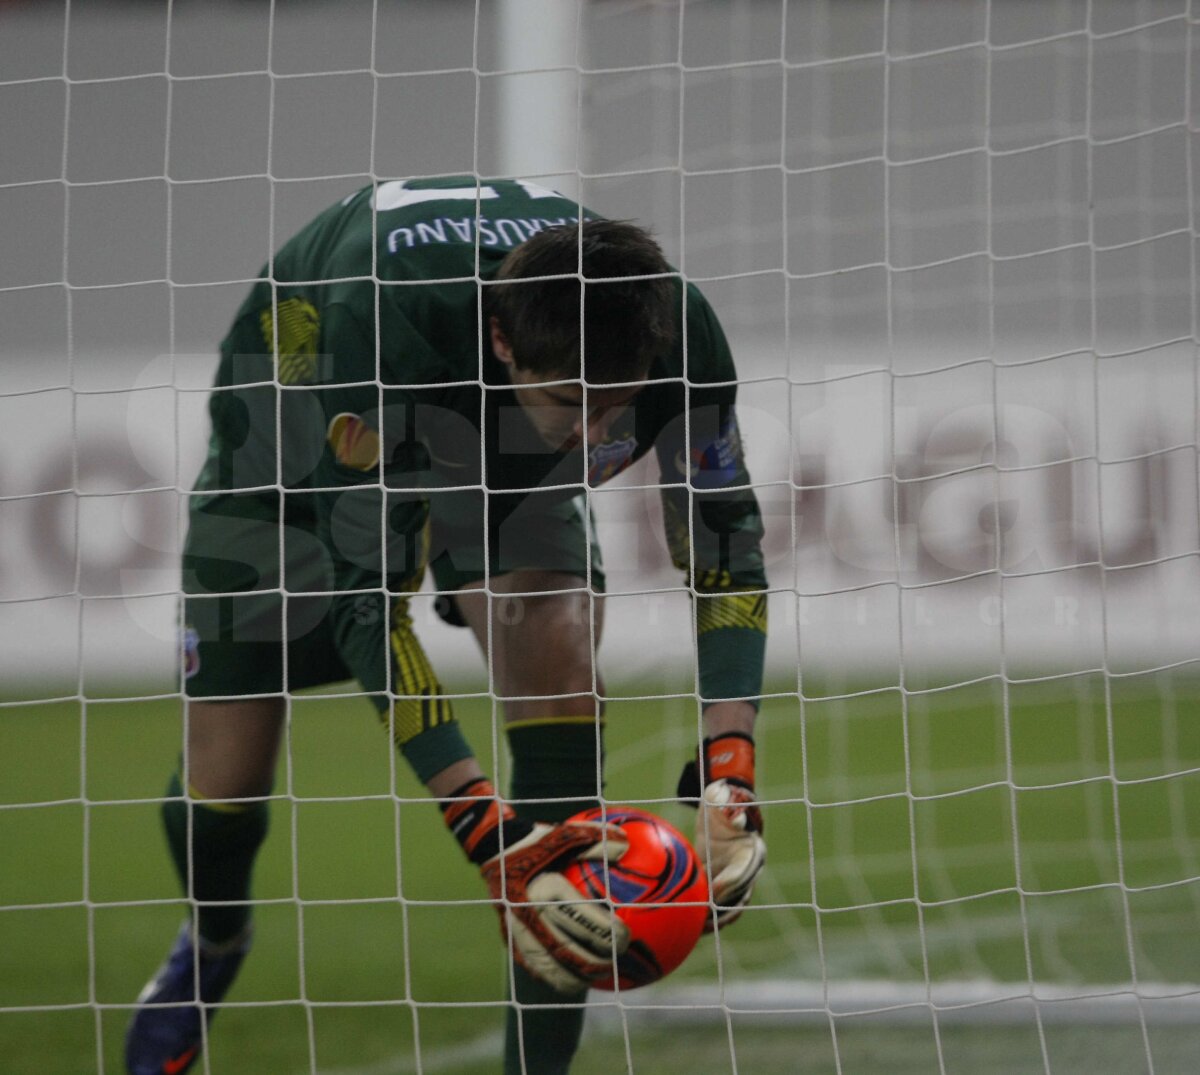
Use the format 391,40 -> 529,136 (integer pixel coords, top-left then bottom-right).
309,302 -> 629,992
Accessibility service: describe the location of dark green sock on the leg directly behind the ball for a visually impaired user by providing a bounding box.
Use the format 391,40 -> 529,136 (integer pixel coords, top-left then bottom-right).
504,717 -> 604,1075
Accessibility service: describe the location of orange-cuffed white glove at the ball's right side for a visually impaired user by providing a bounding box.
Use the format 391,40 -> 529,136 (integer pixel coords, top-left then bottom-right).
679,734 -> 767,932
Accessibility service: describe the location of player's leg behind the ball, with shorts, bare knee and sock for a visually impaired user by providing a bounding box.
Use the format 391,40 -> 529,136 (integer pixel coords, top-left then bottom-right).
431,493 -> 604,1075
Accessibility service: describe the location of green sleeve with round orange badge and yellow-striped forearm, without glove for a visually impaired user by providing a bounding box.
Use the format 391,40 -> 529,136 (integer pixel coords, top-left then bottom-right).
313,304 -> 458,782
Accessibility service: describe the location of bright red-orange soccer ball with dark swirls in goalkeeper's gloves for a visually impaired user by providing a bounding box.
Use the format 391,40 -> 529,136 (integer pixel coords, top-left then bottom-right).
563,806 -> 710,990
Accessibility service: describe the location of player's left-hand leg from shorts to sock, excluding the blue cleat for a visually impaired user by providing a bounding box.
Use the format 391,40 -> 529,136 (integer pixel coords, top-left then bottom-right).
163,492 -> 348,944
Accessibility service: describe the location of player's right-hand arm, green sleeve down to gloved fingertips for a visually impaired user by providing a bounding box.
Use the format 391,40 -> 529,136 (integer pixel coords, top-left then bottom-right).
656,292 -> 767,926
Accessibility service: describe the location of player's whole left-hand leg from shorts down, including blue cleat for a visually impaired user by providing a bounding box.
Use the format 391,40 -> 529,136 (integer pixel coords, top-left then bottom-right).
126,482 -> 347,1075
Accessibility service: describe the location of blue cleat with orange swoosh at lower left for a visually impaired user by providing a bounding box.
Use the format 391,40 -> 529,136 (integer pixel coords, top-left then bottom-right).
125,923 -> 251,1075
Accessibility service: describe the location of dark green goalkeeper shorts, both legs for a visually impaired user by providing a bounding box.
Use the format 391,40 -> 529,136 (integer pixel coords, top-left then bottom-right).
181,479 -> 605,698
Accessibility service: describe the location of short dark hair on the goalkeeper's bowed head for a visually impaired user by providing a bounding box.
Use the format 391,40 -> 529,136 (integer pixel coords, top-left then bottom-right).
486,221 -> 682,384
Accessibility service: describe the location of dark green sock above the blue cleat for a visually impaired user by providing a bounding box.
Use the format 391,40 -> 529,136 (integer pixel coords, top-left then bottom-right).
162,773 -> 268,944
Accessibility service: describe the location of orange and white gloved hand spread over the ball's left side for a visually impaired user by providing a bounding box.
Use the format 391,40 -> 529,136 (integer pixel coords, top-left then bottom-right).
442,780 -> 629,993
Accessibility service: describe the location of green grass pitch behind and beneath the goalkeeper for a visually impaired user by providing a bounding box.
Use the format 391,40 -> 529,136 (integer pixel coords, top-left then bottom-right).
0,673 -> 1200,1075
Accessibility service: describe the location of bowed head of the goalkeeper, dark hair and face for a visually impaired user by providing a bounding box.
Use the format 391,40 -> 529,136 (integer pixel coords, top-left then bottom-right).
487,221 -> 679,449
